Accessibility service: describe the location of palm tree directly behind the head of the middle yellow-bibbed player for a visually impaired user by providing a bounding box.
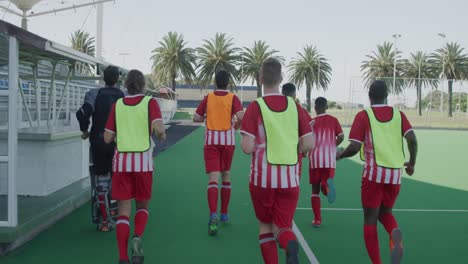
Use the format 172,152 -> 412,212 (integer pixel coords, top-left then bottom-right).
241,40 -> 283,97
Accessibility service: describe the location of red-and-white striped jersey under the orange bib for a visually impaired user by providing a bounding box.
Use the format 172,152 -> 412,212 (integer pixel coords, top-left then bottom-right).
195,90 -> 244,146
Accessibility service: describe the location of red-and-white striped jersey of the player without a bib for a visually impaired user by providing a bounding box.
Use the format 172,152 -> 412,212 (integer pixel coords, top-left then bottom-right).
309,114 -> 343,169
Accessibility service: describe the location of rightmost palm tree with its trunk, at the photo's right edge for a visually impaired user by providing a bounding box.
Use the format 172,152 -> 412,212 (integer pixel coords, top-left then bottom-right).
431,42 -> 468,117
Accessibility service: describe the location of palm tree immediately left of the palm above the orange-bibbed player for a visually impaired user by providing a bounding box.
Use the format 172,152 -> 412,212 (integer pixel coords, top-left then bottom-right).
151,32 -> 196,91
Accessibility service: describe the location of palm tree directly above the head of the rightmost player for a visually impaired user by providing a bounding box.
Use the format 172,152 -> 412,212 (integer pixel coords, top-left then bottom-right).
361,42 -> 404,94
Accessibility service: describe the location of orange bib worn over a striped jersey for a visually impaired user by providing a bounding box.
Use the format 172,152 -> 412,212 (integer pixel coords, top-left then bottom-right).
206,93 -> 234,131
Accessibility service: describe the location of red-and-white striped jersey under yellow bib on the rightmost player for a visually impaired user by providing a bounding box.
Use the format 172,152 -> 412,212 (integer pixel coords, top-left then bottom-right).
349,105 -> 413,184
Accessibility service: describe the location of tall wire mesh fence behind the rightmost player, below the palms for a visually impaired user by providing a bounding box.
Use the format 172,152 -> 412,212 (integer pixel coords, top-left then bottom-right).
336,77 -> 468,129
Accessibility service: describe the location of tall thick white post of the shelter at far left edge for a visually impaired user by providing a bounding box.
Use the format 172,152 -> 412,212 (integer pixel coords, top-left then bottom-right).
8,37 -> 19,227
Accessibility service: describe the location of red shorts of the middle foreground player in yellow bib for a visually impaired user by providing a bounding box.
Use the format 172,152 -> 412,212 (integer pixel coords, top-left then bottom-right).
250,184 -> 299,228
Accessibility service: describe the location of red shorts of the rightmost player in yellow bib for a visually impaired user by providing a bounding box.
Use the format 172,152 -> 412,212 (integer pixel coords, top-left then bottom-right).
361,178 -> 400,208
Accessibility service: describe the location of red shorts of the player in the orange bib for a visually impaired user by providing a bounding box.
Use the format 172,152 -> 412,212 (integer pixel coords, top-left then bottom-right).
203,145 -> 236,173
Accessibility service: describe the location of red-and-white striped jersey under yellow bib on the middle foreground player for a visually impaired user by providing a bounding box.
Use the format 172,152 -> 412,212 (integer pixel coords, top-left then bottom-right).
241,94 -> 312,189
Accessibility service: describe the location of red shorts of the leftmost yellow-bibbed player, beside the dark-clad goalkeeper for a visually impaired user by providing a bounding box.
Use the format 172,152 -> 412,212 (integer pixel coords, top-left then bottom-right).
112,171 -> 153,201
